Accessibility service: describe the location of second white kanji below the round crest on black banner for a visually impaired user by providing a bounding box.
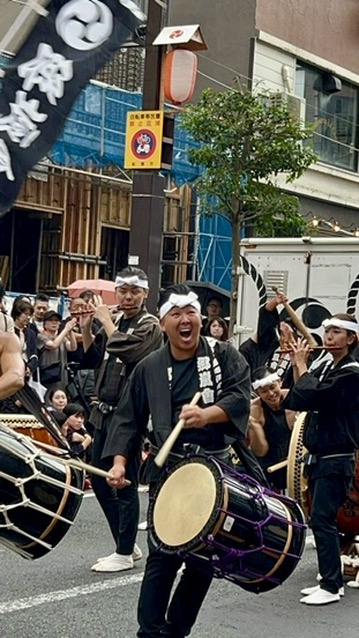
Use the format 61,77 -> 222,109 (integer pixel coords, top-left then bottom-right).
0,91 -> 48,148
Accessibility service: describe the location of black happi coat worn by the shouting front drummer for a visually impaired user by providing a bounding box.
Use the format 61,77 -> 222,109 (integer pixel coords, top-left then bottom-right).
103,337 -> 250,458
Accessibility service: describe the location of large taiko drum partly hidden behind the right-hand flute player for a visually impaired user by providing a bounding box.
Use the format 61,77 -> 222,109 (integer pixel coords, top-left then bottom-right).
287,412 -> 359,538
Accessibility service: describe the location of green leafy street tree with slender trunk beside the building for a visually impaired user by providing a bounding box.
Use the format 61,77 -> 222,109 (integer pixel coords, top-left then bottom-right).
180,88 -> 316,329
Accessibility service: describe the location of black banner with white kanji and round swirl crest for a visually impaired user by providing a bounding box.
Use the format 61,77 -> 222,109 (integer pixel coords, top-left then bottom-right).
0,0 -> 144,217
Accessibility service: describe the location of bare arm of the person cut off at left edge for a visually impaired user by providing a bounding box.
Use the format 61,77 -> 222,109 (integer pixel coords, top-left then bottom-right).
0,333 -> 25,399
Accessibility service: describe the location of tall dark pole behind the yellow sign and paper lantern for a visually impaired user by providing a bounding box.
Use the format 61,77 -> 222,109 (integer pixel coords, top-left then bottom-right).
129,0 -> 167,312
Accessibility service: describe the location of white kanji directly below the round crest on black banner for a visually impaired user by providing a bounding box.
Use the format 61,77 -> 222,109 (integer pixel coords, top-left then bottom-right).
17,42 -> 74,106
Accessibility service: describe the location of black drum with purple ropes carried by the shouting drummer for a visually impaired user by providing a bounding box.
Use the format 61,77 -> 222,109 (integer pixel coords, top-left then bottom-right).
149,457 -> 306,593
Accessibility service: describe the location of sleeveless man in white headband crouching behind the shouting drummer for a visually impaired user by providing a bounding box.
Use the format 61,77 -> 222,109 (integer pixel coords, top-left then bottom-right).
248,367 -> 296,492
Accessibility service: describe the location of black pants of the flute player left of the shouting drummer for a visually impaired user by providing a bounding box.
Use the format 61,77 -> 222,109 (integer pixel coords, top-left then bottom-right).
91,415 -> 140,556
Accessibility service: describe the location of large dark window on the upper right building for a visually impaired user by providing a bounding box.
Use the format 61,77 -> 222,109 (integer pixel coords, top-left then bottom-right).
295,64 -> 358,171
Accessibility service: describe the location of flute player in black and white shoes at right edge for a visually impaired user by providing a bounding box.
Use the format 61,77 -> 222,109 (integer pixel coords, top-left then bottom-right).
284,314 -> 359,605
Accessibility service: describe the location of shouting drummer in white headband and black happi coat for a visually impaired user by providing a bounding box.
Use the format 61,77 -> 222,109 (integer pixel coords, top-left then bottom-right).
104,284 -> 250,638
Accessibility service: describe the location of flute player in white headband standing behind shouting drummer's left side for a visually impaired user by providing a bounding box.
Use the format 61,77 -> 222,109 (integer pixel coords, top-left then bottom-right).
80,266 -> 163,572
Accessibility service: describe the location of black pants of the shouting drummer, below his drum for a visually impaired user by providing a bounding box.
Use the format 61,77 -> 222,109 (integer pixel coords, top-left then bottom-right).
137,547 -> 212,638
